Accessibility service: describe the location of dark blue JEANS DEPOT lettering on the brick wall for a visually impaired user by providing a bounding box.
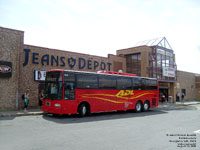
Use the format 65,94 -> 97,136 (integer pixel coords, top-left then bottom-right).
23,49 -> 112,71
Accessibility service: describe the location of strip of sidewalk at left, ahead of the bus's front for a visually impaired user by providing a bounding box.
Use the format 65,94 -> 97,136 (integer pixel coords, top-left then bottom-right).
0,108 -> 43,117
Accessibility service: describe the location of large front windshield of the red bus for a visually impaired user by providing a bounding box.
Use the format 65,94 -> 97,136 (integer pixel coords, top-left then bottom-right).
44,71 -> 63,100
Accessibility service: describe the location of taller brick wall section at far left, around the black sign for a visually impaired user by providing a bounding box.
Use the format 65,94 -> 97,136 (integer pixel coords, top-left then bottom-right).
0,27 -> 24,110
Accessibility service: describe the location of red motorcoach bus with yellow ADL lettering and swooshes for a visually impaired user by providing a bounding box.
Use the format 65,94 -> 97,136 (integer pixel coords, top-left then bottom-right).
42,70 -> 159,116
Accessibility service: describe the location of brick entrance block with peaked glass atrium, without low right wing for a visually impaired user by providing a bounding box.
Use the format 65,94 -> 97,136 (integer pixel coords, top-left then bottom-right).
117,37 -> 177,101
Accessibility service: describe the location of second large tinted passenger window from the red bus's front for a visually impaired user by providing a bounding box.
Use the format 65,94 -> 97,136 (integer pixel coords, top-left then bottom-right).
99,76 -> 117,89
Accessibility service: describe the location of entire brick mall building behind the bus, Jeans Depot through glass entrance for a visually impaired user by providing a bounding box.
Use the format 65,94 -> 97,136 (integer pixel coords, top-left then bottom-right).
0,27 -> 200,110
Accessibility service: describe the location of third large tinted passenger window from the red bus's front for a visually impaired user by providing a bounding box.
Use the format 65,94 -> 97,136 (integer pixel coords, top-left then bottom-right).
117,77 -> 132,90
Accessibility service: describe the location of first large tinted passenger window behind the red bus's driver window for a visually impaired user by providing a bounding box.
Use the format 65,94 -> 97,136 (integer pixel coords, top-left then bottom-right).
77,74 -> 98,89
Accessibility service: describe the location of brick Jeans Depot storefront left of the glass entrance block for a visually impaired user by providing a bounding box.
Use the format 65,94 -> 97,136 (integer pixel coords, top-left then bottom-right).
0,27 -> 126,110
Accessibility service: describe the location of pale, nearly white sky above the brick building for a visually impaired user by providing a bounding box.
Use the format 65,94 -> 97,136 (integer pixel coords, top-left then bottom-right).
0,0 -> 200,74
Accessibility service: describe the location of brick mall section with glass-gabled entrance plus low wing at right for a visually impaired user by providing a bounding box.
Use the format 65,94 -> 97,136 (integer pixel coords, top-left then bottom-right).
117,37 -> 200,102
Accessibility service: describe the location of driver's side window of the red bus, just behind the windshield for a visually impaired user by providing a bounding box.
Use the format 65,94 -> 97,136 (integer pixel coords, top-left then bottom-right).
64,82 -> 75,100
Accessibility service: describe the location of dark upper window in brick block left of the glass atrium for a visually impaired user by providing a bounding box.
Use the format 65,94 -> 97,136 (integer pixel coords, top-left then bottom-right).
126,53 -> 141,76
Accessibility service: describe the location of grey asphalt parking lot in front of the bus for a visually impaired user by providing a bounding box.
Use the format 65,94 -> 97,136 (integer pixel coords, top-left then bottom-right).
0,104 -> 200,150
